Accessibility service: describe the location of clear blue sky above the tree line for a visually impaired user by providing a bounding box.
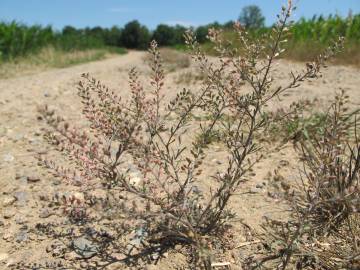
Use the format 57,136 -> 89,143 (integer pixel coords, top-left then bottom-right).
0,0 -> 360,29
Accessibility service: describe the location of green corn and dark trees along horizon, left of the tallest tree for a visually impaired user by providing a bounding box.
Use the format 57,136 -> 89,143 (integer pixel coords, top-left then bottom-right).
0,20 -> 235,59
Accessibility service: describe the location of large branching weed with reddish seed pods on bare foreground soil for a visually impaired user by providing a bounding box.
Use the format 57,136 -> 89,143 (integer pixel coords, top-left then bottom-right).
34,1 -> 346,269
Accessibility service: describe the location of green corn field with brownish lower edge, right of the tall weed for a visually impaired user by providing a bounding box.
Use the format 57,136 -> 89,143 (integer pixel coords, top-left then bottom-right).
203,14 -> 360,66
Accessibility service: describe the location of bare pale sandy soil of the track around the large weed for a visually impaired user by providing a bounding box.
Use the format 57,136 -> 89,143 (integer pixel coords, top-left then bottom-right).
0,52 -> 360,269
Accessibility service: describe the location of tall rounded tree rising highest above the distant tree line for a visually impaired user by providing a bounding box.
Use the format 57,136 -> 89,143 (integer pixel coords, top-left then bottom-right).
239,5 -> 265,29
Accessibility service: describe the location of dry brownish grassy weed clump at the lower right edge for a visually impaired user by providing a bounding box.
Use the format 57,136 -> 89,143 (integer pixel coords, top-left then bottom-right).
254,92 -> 360,269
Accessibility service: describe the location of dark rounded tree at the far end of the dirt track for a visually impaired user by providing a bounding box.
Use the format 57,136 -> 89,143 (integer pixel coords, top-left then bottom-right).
121,20 -> 150,49
